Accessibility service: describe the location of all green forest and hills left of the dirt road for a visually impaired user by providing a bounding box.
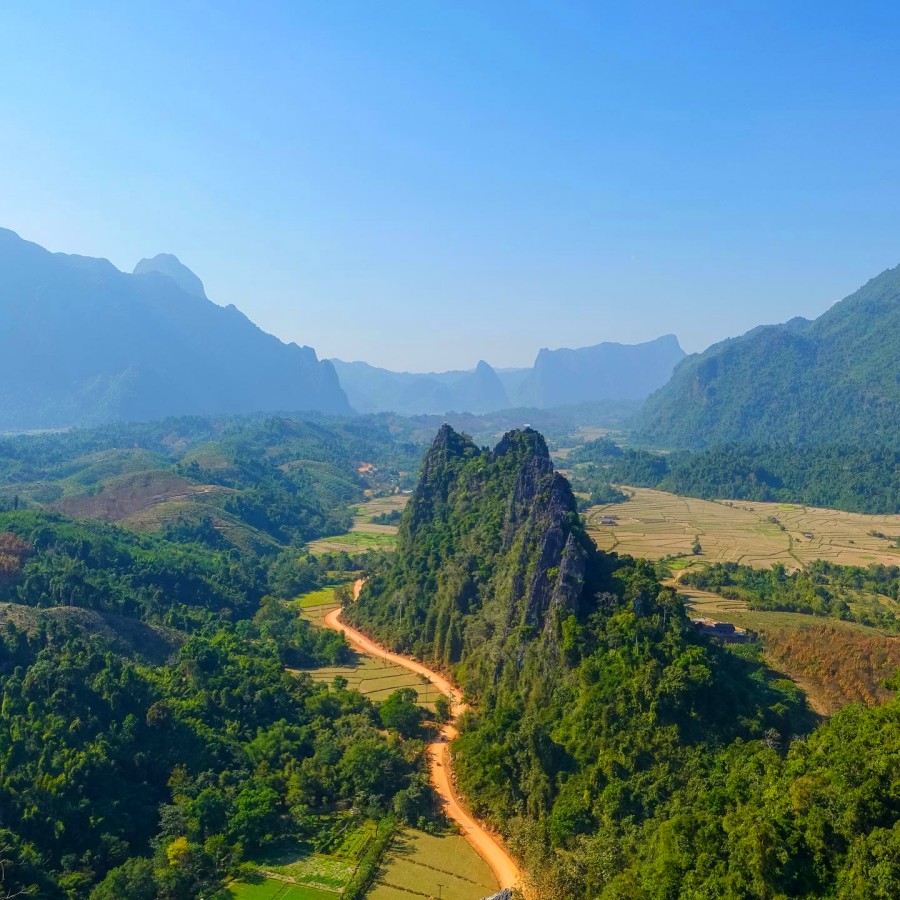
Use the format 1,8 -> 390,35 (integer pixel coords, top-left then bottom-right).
0,418 -> 431,900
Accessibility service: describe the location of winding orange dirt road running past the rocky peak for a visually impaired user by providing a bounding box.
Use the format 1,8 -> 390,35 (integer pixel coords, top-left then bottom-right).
324,581 -> 524,889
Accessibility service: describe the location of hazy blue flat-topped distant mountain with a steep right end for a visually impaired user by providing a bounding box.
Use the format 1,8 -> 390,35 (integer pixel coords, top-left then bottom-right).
514,334 -> 685,409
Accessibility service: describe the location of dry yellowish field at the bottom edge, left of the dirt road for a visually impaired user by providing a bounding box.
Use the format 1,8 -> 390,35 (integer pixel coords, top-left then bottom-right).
367,829 -> 498,900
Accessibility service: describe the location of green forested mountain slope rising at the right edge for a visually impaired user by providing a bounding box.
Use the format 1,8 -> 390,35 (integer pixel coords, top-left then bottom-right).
635,267 -> 900,448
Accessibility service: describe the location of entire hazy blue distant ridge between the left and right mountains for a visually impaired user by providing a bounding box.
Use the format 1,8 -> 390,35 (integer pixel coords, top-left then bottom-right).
331,334 -> 685,415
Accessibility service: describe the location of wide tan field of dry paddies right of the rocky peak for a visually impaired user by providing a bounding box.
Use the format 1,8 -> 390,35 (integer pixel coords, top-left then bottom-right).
586,488 -> 900,569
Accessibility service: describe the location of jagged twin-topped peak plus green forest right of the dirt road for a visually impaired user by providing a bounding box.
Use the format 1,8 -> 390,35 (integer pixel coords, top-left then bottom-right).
347,428 -> 900,900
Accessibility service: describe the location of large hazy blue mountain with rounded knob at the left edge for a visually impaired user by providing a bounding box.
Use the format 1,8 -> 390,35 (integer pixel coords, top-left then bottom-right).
0,229 -> 352,430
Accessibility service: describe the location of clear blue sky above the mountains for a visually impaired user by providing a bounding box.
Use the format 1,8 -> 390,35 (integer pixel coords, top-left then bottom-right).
0,0 -> 900,370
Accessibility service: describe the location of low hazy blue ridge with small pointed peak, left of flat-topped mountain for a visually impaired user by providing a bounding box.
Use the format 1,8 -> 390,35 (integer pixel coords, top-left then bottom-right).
331,359 -> 511,415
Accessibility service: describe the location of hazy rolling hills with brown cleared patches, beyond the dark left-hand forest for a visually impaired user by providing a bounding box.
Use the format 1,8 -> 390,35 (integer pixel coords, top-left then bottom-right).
0,416 -> 421,553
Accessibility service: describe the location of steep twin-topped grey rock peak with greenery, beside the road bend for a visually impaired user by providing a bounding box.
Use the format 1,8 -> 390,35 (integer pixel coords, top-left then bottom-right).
350,425 -> 603,683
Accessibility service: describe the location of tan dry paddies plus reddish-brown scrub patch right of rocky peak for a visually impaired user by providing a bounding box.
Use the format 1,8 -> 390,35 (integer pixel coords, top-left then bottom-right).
587,488 -> 900,715
